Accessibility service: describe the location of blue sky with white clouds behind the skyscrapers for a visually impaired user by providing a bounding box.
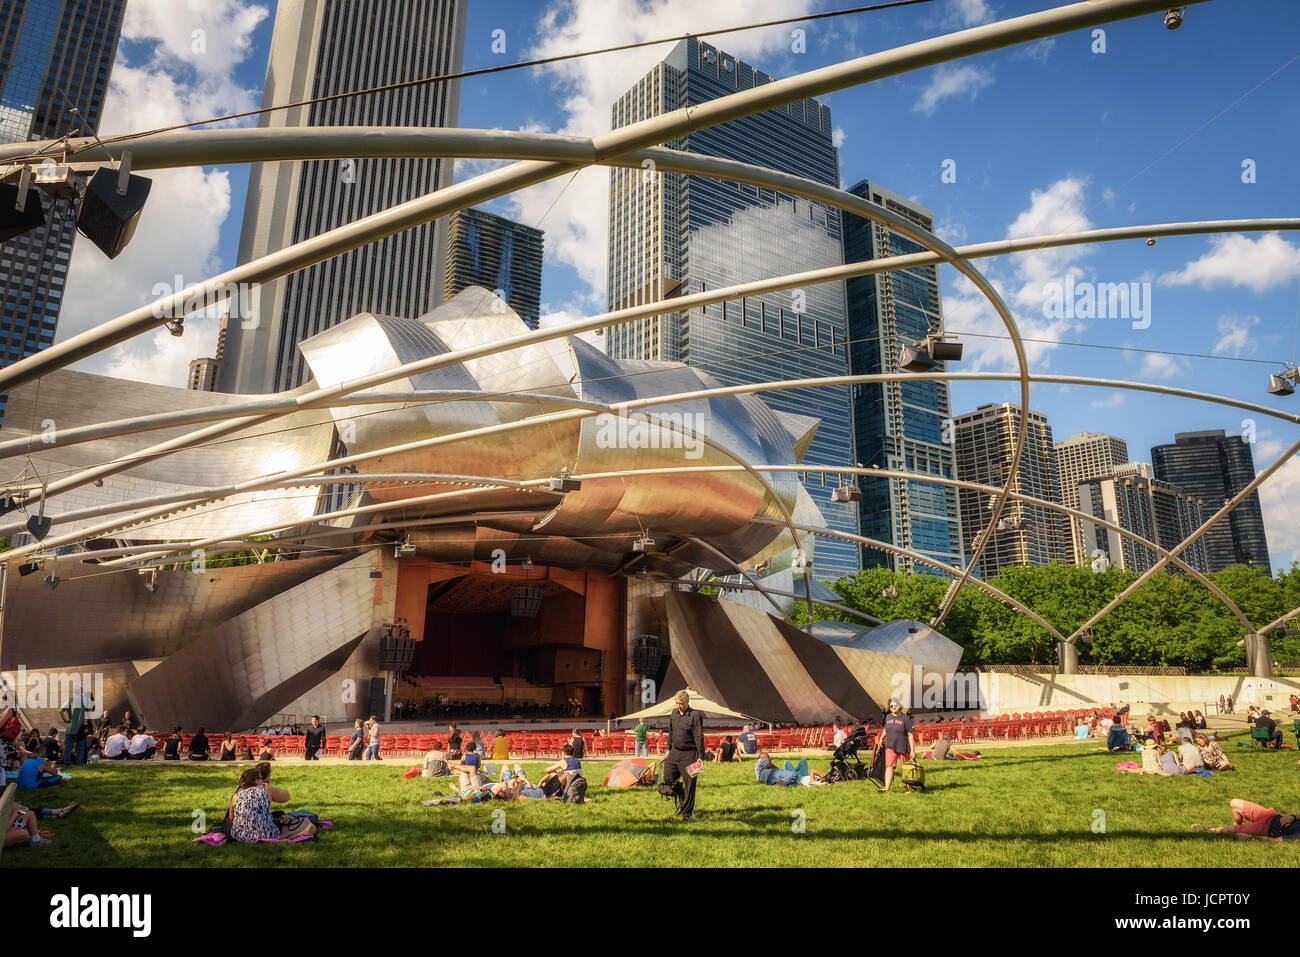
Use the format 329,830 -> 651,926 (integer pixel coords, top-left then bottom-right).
61,0 -> 1300,567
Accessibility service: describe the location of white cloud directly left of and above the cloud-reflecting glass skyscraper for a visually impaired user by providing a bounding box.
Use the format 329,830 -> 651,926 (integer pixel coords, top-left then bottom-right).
508,0 -> 816,311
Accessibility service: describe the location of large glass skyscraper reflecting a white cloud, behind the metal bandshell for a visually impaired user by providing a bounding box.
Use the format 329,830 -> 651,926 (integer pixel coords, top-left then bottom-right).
608,38 -> 859,579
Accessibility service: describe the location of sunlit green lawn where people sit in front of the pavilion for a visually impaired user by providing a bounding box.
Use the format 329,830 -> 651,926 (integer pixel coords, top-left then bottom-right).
10,739 -> 1300,867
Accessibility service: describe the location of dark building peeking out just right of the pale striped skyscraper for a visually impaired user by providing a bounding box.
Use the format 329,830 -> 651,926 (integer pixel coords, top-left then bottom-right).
443,209 -> 543,329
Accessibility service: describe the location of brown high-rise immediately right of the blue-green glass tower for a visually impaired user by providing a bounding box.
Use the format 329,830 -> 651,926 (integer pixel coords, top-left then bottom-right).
953,402 -> 1066,577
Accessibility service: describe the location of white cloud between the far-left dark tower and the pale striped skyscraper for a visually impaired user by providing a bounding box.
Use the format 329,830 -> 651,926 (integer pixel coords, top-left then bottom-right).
59,0 -> 268,386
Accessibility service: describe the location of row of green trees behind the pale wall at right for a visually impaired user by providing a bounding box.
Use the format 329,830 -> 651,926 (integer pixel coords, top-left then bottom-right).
794,564 -> 1300,671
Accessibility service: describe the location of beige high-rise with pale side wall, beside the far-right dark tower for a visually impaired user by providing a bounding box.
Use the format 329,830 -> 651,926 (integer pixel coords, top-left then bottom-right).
1076,465 -> 1209,572
